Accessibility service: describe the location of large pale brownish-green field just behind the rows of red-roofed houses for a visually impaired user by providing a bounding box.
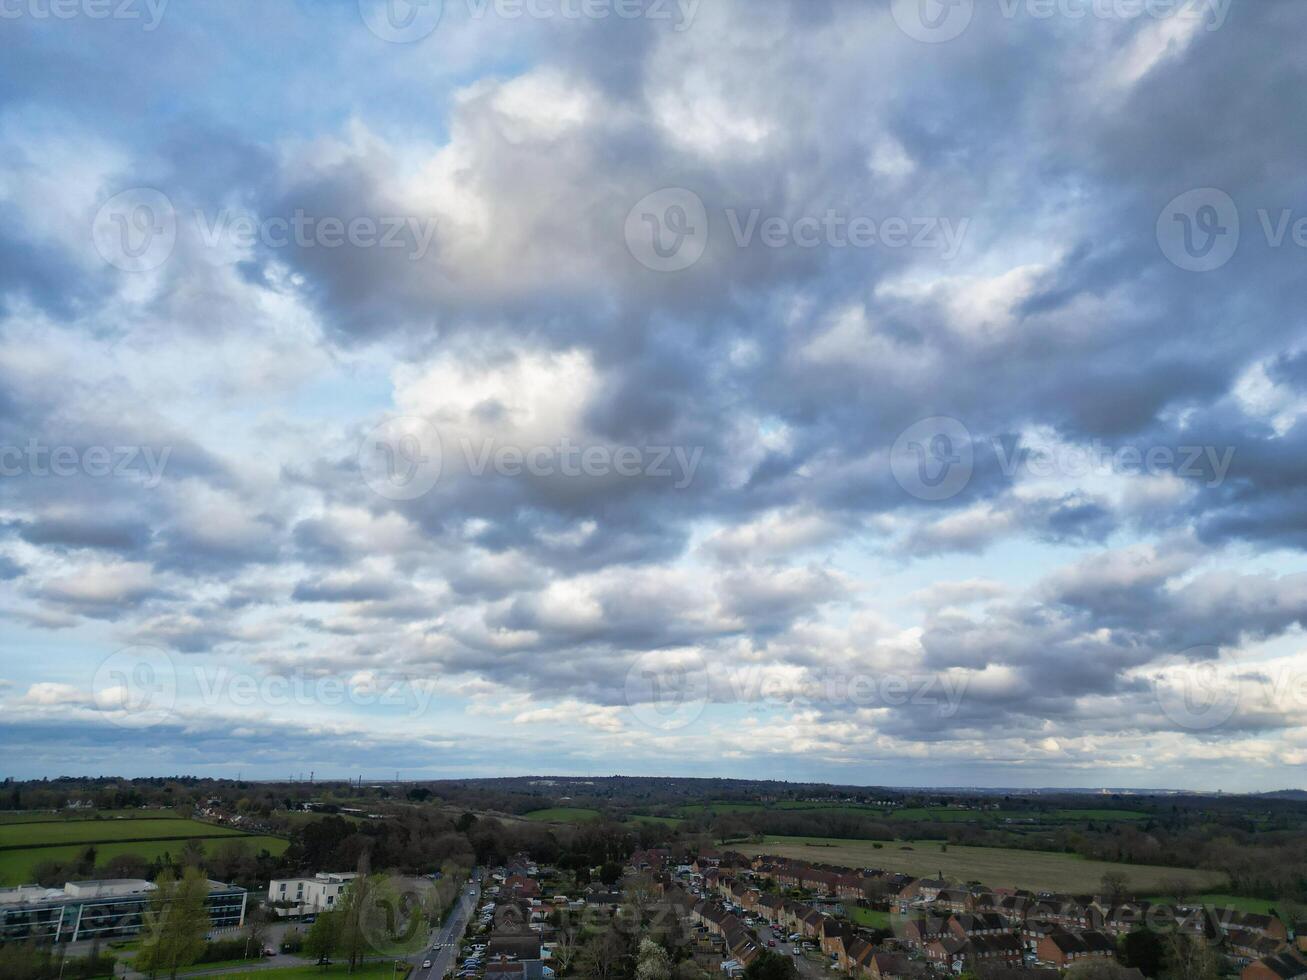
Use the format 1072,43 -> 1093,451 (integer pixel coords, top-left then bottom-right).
737,838 -> 1226,894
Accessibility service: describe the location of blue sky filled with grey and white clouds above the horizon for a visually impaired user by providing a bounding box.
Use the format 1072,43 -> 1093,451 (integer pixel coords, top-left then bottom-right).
0,0 -> 1307,791
